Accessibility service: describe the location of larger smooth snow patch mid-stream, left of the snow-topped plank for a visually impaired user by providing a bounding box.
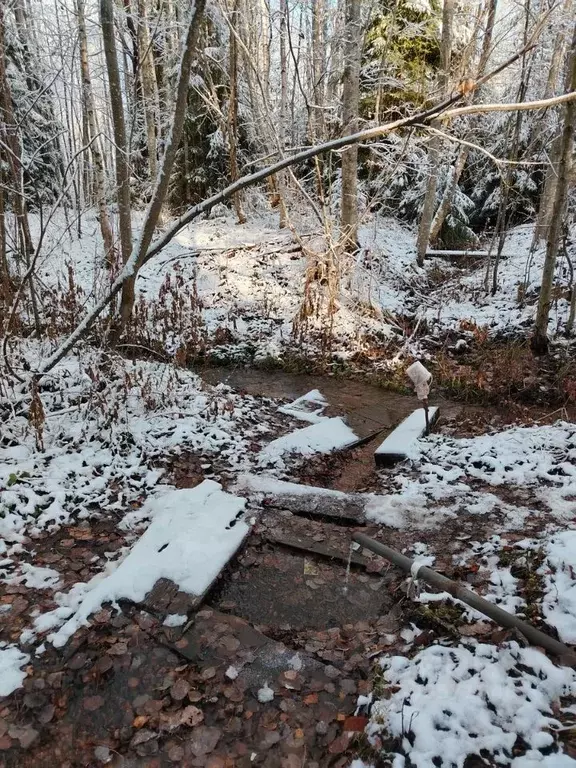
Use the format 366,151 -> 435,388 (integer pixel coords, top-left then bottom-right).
260,416 -> 358,464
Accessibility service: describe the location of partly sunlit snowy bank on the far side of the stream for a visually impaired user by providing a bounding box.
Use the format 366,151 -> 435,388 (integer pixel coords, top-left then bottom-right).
21,207 -> 568,368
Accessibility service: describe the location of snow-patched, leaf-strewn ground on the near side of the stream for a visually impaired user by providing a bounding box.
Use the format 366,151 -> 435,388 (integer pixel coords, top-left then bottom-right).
0,349 -> 576,768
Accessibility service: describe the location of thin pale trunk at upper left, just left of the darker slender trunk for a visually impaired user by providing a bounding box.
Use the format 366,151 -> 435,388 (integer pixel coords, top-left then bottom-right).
76,0 -> 115,269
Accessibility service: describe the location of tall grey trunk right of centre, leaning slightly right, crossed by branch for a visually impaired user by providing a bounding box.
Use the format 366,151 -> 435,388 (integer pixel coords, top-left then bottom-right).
416,0 -> 454,267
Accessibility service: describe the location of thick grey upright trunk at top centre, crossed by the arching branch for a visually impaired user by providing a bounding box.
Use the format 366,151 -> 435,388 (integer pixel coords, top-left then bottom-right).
340,0 -> 362,252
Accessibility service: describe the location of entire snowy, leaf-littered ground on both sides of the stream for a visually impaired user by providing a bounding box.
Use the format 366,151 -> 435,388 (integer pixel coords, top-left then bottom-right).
0,212 -> 576,768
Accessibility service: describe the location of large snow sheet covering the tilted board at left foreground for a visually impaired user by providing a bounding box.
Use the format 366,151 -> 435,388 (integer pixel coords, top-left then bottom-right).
35,480 -> 249,648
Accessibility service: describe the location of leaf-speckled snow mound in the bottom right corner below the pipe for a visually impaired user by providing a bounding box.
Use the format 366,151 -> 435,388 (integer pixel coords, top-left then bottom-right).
368,643 -> 576,768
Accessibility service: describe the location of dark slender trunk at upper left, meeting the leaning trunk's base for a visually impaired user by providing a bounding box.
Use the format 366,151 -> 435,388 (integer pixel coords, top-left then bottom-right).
100,0 -> 132,264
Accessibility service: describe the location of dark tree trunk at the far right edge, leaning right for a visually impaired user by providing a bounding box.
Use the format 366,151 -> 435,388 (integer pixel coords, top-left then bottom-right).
531,25 -> 576,353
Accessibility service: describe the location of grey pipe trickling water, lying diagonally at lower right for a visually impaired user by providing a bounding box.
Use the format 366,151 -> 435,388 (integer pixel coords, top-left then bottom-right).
352,533 -> 576,667
